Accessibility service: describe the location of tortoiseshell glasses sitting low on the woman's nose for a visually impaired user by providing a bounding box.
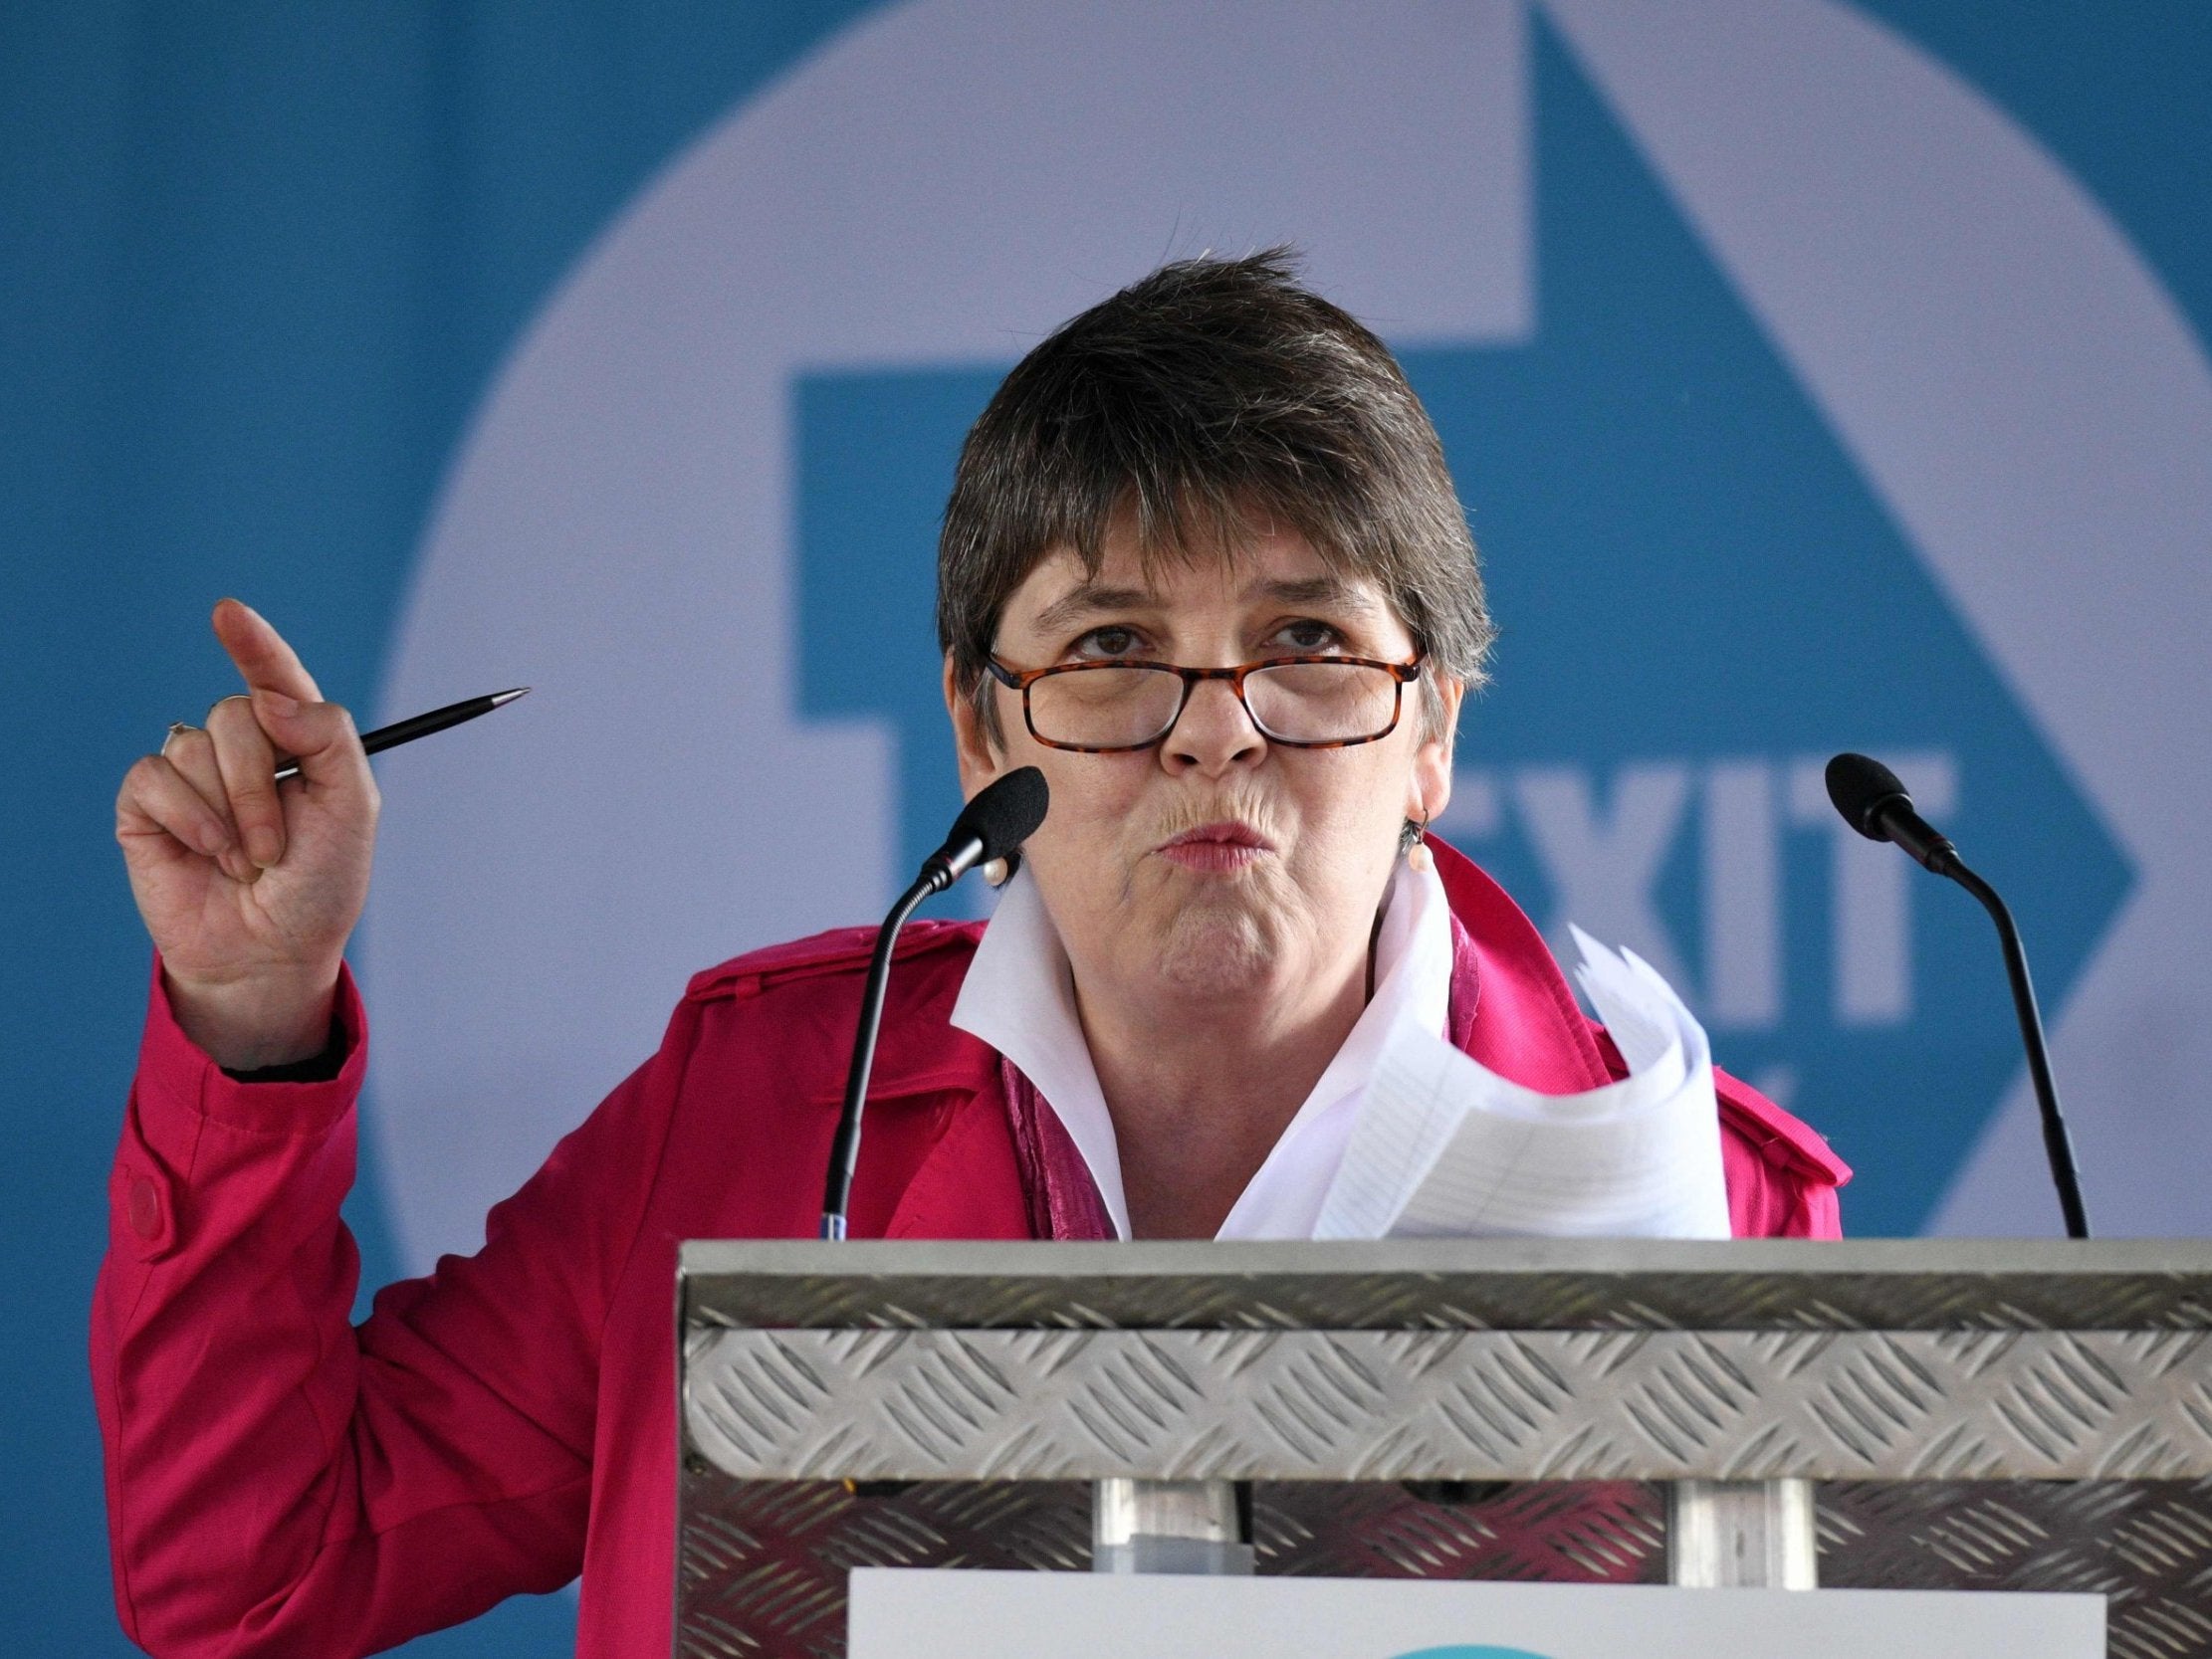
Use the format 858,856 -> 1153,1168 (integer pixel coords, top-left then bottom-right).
987,657 -> 1421,754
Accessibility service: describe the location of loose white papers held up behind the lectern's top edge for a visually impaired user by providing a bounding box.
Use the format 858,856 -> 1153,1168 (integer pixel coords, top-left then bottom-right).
1314,927 -> 1727,1239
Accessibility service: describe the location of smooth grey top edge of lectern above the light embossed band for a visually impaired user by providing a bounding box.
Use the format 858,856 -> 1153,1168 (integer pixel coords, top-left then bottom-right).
684,1239 -> 2212,1332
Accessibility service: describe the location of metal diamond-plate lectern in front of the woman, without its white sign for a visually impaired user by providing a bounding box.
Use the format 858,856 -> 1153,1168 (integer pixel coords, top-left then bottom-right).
677,1239 -> 2212,1659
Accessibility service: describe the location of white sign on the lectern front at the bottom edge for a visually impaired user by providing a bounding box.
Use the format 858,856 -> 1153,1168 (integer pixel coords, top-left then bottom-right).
849,1568 -> 2103,1659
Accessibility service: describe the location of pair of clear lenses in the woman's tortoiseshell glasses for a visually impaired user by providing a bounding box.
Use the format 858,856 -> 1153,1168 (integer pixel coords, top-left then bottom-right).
1028,662 -> 1398,749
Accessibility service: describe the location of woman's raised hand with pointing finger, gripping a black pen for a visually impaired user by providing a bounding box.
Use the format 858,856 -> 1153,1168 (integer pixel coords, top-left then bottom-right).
115,599 -> 378,1071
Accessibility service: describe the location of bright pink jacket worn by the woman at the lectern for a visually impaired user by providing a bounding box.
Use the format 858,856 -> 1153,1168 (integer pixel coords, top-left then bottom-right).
91,845 -> 1850,1659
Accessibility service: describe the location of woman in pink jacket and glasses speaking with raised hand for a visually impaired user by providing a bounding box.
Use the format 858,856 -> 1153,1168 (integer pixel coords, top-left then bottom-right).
93,255 -> 1845,1657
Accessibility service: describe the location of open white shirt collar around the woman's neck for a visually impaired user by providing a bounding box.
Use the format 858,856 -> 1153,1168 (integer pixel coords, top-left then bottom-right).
951,863 -> 1451,1239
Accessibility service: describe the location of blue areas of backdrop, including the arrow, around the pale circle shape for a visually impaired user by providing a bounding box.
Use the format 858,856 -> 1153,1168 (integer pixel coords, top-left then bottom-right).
0,0 -> 2212,1655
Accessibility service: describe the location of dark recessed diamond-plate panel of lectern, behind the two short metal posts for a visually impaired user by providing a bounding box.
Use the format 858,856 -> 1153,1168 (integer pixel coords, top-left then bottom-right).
677,1471 -> 2212,1659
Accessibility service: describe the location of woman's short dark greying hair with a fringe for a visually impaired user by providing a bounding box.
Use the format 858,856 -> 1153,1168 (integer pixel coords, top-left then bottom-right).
938,248 -> 1495,736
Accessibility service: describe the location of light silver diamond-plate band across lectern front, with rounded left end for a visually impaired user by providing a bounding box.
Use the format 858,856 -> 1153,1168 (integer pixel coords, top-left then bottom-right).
686,1330 -> 2212,1480
